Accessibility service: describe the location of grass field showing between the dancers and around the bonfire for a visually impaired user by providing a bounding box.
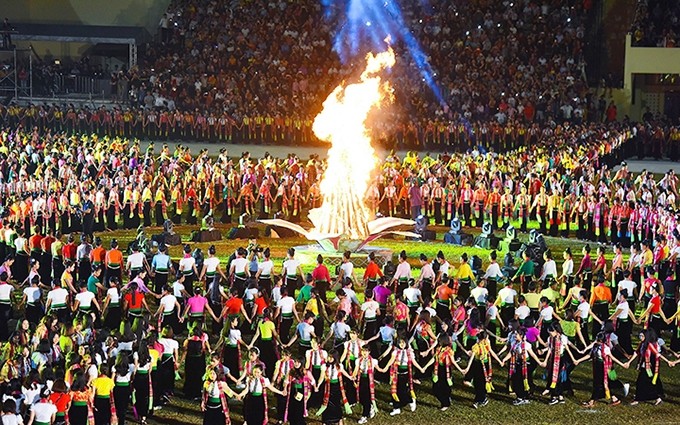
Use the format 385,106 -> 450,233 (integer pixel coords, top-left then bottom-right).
103,220 -> 680,425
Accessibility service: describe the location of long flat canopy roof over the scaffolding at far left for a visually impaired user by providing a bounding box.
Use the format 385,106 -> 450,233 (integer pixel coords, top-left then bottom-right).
12,23 -> 151,44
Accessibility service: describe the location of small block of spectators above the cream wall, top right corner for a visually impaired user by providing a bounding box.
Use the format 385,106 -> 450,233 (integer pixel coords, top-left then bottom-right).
631,0 -> 680,47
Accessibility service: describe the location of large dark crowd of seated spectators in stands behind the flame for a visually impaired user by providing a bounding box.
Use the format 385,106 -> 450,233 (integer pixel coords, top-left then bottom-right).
7,0 -> 652,142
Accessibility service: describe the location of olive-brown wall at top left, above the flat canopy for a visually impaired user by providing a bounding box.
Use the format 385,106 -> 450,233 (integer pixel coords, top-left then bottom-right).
0,0 -> 170,34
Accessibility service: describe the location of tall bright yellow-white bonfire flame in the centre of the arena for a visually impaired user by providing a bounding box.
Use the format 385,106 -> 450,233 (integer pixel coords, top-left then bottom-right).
309,48 -> 395,239
